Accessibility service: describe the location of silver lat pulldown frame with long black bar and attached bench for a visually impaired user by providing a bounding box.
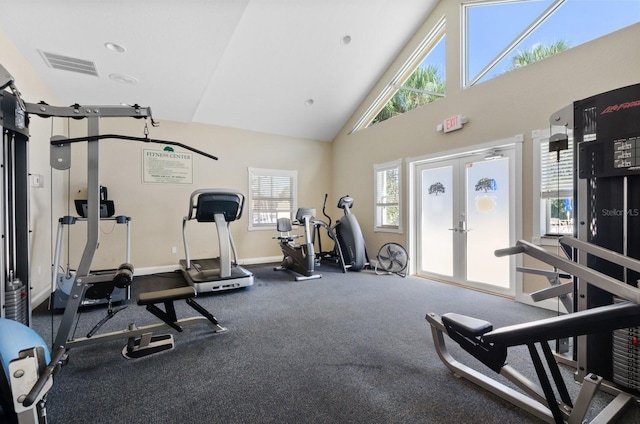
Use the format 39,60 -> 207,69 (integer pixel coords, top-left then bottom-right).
39,99 -> 226,357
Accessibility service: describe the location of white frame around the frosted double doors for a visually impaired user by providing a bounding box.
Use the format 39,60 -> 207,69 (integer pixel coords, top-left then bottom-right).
405,134 -> 526,302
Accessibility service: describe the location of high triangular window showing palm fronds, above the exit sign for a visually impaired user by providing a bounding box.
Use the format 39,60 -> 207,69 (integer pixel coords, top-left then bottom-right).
353,19 -> 446,131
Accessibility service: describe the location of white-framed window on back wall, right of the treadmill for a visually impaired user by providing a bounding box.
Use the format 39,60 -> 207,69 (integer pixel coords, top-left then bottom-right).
249,168 -> 298,230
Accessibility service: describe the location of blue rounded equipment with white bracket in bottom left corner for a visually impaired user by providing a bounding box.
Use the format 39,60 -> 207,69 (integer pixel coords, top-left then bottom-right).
0,318 -> 64,424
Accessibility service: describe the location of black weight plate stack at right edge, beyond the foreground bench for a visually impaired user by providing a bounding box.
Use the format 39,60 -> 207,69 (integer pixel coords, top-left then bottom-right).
613,327 -> 640,390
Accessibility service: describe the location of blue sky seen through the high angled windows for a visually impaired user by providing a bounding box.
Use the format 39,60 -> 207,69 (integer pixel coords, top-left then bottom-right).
356,0 -> 640,128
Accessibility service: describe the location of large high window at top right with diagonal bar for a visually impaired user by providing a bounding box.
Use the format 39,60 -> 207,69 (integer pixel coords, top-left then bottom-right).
462,0 -> 640,86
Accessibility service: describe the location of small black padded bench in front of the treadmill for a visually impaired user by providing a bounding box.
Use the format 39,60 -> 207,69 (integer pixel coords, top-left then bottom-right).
122,286 -> 226,359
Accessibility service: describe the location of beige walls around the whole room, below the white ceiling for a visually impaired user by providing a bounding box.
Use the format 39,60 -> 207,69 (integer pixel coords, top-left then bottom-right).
0,8 -> 640,306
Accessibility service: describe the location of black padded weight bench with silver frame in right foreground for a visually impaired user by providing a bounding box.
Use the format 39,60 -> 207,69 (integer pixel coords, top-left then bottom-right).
426,301 -> 640,424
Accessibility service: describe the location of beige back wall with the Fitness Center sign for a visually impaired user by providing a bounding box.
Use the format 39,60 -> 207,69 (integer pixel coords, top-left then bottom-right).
60,113 -> 331,269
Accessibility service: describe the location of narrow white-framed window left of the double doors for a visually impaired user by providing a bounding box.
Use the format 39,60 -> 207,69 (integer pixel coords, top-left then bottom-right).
373,160 -> 402,232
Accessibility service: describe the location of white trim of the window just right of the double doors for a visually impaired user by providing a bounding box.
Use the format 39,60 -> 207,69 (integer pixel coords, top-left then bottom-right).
531,126 -> 572,246
